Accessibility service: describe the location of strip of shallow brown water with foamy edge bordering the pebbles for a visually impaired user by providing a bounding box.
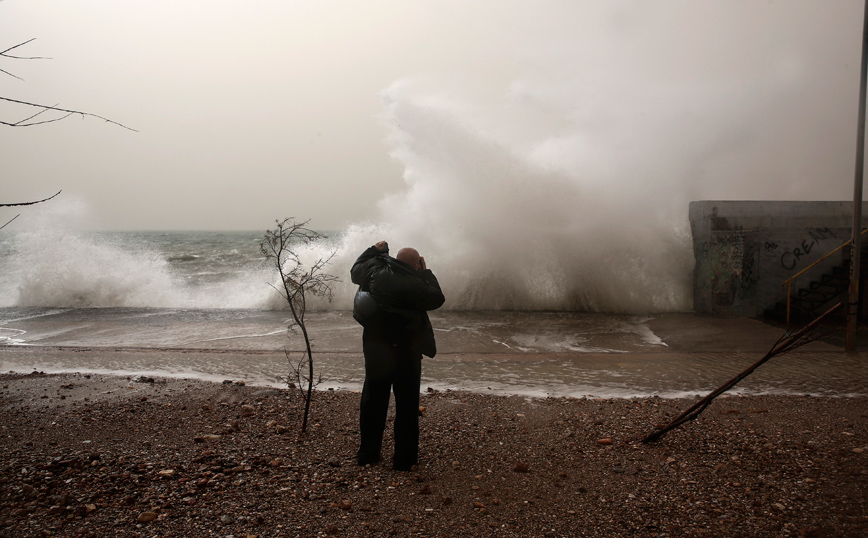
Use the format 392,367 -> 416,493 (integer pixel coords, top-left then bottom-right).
0,330 -> 868,398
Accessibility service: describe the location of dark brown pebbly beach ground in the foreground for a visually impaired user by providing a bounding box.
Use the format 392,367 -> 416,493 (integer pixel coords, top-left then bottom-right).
0,373 -> 868,538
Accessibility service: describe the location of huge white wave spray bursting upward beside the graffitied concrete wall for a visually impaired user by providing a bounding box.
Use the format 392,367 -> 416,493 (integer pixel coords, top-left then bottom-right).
303,79 -> 693,313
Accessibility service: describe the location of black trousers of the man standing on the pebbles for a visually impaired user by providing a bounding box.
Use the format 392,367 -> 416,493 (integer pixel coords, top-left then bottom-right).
357,329 -> 422,471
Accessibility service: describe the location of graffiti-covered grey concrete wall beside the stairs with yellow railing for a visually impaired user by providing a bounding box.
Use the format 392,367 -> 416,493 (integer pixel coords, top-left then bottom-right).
690,201 -> 868,317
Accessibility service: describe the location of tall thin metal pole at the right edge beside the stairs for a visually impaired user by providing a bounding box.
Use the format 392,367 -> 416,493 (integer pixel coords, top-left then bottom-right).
846,0 -> 868,351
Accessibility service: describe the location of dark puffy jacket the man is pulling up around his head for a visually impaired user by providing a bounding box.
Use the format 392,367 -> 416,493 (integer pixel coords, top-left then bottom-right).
350,246 -> 446,357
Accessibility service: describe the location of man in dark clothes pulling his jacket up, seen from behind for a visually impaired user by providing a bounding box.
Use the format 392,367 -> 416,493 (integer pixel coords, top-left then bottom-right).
350,241 -> 445,471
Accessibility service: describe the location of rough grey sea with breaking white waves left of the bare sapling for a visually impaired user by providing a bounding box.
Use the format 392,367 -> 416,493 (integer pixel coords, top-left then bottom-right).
0,228 -> 275,309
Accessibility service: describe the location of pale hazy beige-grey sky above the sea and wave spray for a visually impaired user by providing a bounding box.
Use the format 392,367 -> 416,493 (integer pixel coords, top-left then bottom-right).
0,0 -> 864,229
